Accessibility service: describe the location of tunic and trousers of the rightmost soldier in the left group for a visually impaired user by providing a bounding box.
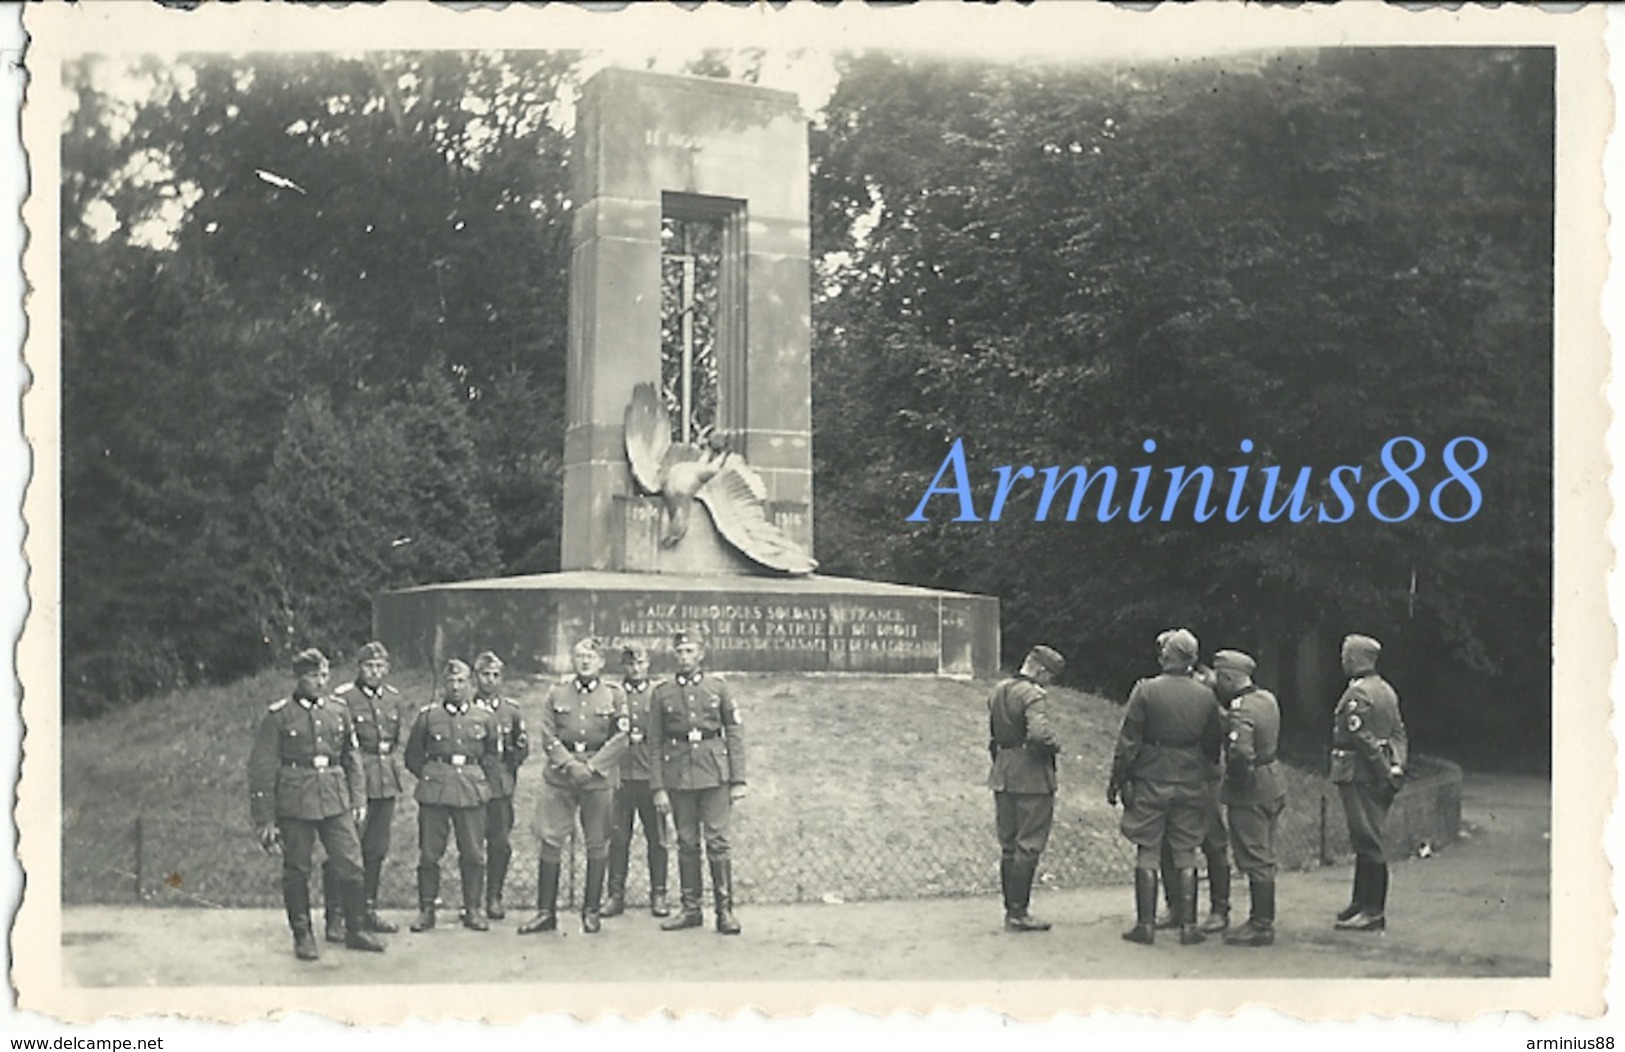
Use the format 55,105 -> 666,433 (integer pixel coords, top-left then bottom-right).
648,670 -> 744,862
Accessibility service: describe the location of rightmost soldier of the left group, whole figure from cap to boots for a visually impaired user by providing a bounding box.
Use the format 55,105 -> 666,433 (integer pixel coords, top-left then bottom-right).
648,631 -> 746,935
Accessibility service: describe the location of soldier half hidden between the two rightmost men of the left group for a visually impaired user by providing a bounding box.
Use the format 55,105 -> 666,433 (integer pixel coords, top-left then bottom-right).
605,642 -> 671,917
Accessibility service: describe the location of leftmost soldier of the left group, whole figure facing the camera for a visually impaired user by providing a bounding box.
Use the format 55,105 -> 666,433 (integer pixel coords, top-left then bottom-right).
249,650 -> 384,961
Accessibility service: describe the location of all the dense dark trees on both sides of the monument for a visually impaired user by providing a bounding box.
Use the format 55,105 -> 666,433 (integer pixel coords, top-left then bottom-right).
62,49 -> 1554,757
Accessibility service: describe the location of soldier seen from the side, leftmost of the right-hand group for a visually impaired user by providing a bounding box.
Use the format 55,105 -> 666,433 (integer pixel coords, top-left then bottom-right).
988,646 -> 1066,932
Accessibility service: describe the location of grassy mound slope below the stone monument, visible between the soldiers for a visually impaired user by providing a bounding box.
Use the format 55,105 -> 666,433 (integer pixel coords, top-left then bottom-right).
62,673 -> 1339,907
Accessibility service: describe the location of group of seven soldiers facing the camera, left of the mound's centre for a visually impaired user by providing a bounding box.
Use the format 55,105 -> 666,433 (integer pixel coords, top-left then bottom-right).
249,631 -> 744,961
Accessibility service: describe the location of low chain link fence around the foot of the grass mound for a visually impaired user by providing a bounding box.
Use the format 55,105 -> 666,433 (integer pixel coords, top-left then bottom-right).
63,769 -> 1461,911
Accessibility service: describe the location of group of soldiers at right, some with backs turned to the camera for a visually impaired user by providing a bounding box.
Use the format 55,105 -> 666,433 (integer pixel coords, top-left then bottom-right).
988,628 -> 1409,946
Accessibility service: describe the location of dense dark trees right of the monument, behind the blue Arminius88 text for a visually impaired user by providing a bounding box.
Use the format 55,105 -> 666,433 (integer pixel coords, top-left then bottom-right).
814,49 -> 1552,757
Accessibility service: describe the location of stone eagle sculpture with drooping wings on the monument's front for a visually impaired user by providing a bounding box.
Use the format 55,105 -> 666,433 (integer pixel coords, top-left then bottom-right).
626,384 -> 817,574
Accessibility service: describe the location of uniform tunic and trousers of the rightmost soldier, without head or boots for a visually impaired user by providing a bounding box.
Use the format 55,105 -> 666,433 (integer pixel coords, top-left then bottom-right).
1331,672 -> 1411,863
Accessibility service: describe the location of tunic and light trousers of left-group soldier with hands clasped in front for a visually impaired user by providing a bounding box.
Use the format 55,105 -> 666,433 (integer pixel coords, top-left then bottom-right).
535,676 -> 631,862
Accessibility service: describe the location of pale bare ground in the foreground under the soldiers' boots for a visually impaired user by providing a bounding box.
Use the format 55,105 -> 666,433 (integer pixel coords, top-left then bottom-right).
62,774 -> 1552,987
